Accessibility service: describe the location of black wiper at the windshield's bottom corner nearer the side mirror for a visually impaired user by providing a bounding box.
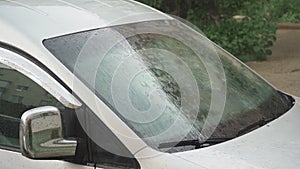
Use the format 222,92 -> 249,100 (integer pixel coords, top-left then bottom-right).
158,138 -> 233,149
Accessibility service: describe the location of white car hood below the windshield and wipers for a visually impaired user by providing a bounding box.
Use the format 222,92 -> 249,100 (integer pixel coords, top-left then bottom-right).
174,97 -> 300,169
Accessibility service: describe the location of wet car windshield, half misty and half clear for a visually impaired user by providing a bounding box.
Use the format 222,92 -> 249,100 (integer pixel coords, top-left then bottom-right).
43,20 -> 291,151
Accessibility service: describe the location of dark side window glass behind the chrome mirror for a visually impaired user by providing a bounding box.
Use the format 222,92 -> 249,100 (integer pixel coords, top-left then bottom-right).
0,63 -> 64,148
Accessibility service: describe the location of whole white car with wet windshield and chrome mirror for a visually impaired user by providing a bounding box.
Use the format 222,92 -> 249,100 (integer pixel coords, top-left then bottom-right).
0,0 -> 300,169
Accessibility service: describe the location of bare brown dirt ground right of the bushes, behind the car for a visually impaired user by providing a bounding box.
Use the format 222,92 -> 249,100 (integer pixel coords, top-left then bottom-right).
247,29 -> 300,97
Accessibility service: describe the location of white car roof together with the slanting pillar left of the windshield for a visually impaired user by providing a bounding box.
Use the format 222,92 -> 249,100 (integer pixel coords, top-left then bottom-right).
0,0 -> 159,154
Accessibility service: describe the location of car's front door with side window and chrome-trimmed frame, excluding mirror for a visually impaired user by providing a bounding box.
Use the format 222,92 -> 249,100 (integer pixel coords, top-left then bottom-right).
0,48 -> 94,169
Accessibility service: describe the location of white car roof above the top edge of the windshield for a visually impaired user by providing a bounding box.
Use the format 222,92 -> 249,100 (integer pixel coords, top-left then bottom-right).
0,0 -> 170,54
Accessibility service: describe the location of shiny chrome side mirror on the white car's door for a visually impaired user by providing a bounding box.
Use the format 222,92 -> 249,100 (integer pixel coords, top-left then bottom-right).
20,106 -> 77,159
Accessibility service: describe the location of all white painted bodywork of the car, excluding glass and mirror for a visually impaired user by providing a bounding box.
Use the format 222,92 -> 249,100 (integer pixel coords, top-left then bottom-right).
0,0 -> 300,169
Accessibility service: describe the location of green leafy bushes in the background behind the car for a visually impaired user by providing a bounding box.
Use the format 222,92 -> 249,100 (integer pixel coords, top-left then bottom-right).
136,0 -> 300,61
